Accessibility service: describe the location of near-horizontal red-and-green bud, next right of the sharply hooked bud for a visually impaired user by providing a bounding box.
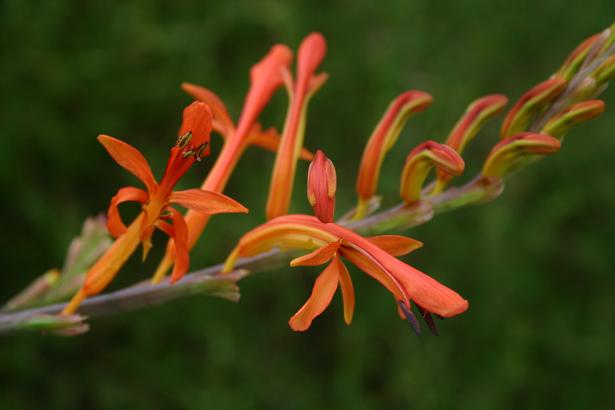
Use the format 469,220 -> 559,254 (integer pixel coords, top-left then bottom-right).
482,132 -> 561,179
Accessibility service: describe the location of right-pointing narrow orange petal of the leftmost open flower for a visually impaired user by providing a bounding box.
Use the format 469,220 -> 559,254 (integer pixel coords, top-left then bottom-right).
169,188 -> 248,215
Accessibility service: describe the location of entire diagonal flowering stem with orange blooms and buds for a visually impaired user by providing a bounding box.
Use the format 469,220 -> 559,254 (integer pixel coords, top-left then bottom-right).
0,25 -> 615,335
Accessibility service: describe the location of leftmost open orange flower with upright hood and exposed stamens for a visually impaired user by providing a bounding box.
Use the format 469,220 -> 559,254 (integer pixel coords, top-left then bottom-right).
63,102 -> 248,314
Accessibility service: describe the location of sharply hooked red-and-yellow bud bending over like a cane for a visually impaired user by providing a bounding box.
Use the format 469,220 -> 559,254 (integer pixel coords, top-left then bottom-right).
399,141 -> 465,204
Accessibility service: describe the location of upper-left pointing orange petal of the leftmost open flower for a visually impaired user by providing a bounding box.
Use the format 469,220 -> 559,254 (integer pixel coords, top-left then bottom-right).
98,135 -> 156,192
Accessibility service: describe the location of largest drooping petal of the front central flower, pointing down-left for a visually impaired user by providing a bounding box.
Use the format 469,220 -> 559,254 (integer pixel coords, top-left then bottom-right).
288,258 -> 341,332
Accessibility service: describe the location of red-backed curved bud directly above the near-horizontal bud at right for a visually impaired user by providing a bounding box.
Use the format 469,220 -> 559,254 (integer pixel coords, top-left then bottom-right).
500,77 -> 566,139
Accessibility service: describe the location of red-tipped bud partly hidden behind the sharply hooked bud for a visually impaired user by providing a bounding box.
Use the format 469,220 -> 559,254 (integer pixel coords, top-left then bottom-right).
432,94 -> 508,194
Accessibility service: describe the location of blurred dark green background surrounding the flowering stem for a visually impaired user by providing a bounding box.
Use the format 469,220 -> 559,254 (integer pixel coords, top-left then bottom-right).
0,0 -> 615,410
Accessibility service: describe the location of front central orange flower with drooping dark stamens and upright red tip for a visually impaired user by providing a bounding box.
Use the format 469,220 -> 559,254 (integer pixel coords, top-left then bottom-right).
223,152 -> 468,333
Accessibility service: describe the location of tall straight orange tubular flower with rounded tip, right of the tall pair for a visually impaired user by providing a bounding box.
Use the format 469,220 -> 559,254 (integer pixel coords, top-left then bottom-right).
266,33 -> 327,219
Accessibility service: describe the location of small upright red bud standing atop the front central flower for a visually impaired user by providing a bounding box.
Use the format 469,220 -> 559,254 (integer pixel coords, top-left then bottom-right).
307,150 -> 337,223
